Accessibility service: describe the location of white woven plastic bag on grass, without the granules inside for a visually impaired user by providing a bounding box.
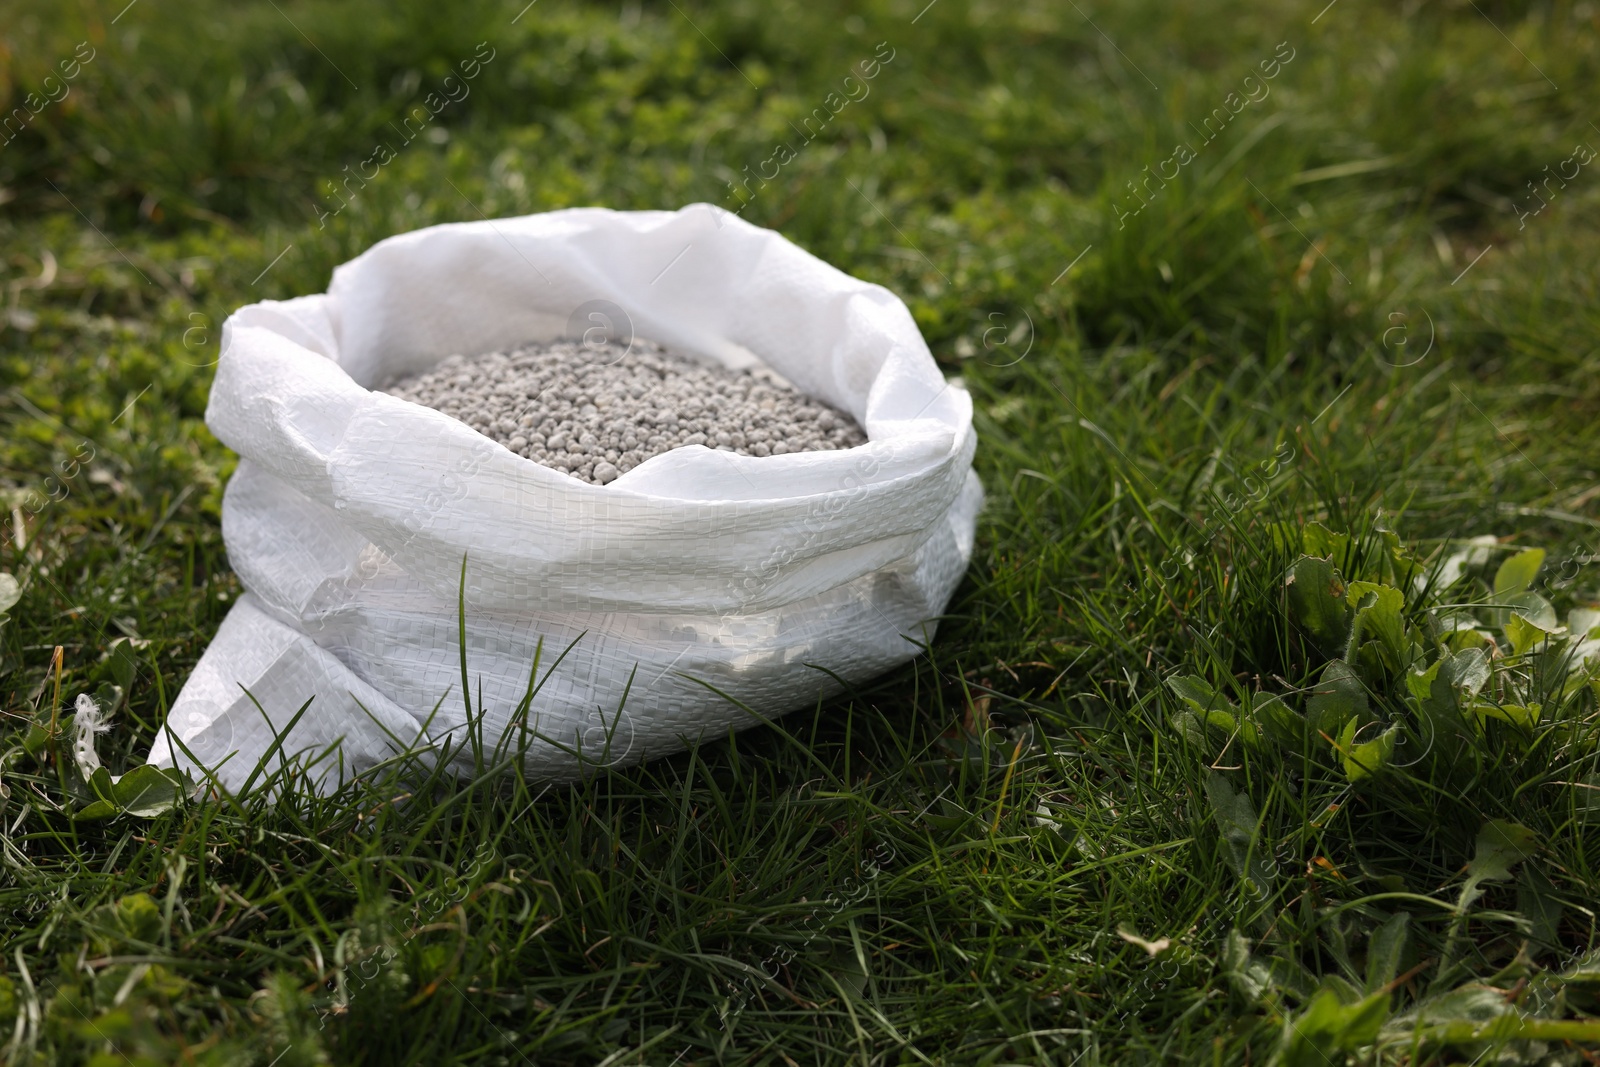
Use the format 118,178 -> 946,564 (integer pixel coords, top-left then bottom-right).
150,205 -> 982,789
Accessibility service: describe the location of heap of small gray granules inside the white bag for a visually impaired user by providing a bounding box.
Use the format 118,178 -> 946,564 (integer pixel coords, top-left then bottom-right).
384,339 -> 867,485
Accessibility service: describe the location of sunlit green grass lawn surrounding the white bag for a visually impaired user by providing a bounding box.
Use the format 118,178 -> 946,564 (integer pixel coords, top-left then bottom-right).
0,0 -> 1600,1067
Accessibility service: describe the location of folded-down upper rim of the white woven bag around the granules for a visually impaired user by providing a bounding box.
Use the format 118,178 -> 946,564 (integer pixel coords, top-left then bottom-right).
206,205 -> 976,611
